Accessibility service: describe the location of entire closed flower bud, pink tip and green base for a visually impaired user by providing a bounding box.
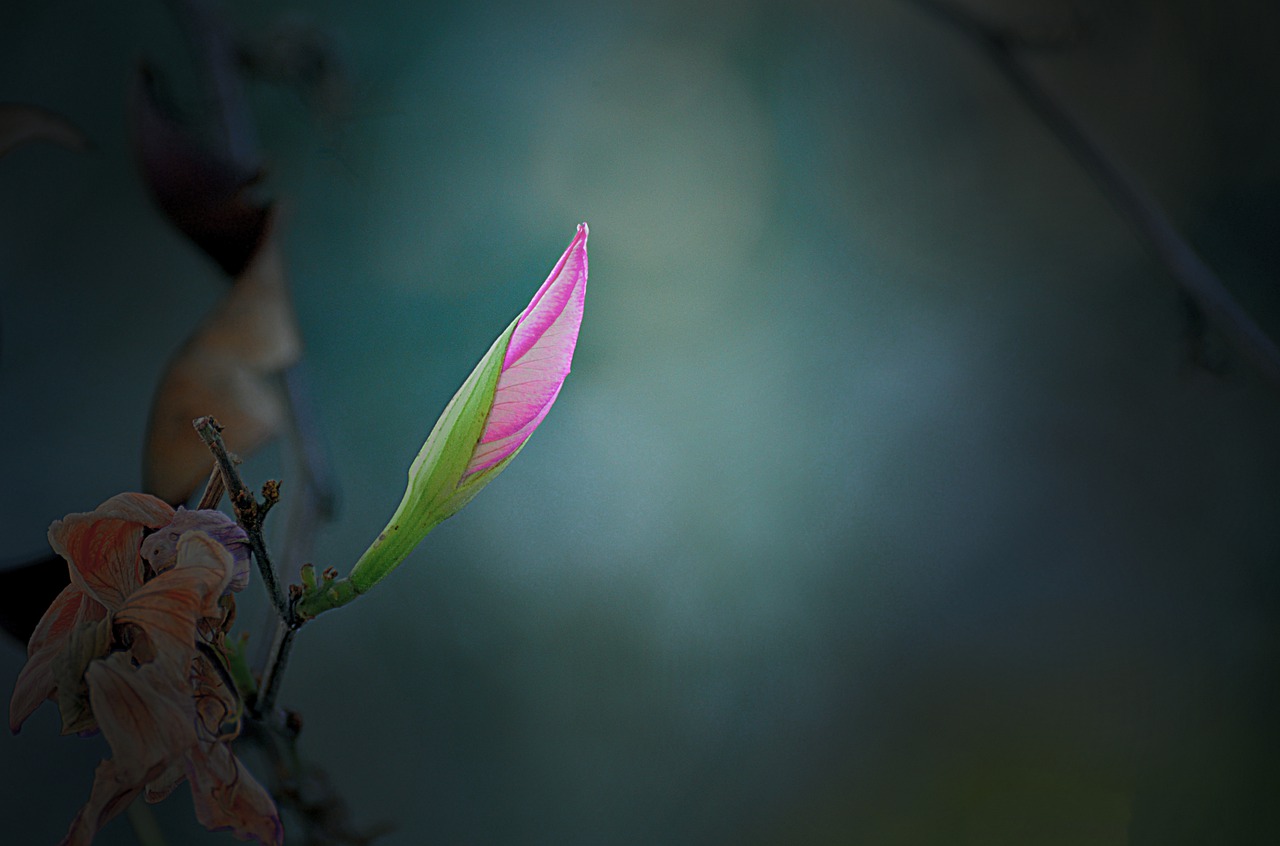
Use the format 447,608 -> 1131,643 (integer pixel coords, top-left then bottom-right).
332,223 -> 588,596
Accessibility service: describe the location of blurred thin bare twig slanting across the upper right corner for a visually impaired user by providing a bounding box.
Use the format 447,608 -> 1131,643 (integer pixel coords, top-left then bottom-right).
915,0 -> 1280,389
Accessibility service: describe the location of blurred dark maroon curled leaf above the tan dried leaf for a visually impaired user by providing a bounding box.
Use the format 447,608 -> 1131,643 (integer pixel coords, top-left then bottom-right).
131,67 -> 270,276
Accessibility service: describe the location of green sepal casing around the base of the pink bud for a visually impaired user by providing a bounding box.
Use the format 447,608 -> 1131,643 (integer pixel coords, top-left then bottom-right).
347,320 -> 516,594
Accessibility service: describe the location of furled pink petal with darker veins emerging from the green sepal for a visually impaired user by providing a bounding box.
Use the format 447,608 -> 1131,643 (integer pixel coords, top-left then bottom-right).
463,223 -> 588,479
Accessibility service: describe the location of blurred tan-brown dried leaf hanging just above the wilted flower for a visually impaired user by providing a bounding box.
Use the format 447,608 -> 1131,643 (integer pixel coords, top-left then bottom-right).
142,223 -> 302,503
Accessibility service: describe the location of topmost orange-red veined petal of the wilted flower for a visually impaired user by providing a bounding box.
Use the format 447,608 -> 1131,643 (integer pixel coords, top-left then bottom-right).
49,493 -> 174,611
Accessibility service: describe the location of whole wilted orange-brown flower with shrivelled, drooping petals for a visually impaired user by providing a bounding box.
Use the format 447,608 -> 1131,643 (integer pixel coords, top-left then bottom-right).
9,493 -> 283,845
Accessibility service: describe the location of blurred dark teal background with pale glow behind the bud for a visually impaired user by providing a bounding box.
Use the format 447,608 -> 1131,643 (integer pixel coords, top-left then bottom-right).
0,0 -> 1280,845
